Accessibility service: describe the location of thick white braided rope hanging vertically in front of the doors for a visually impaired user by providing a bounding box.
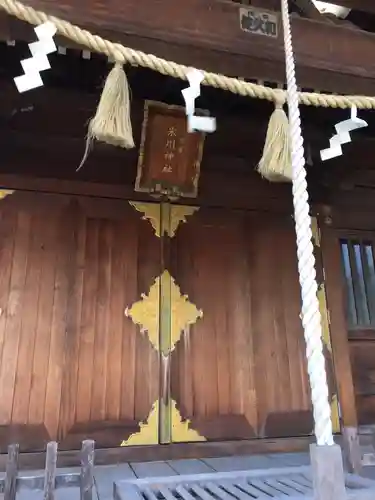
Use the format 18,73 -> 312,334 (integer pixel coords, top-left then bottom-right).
281,0 -> 334,445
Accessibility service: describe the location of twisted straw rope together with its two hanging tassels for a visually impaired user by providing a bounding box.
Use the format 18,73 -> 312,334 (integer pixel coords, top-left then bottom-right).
0,0 -> 375,182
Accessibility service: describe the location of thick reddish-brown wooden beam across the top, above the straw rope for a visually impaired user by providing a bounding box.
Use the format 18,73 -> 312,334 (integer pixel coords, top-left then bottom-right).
2,0 -> 375,92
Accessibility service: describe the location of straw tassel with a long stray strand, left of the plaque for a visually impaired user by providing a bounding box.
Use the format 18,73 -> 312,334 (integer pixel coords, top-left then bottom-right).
77,63 -> 135,171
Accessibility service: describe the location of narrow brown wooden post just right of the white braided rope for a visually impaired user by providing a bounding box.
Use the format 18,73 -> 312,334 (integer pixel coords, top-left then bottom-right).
319,219 -> 357,427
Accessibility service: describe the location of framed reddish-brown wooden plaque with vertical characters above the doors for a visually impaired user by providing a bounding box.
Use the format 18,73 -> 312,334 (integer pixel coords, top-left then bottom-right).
135,101 -> 205,199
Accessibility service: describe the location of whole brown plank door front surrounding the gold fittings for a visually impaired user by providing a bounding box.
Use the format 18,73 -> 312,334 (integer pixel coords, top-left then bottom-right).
0,191 -> 318,450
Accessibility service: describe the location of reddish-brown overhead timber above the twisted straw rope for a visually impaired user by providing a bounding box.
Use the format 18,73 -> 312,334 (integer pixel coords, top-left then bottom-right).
0,0 -> 375,95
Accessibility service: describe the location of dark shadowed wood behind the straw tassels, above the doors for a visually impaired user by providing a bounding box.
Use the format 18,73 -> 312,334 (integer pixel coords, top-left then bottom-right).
0,39 -> 375,209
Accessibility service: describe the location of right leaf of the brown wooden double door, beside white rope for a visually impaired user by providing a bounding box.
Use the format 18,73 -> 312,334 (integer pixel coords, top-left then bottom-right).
164,207 -> 313,442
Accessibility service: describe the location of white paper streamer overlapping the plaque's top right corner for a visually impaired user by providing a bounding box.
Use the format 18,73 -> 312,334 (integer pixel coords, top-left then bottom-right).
181,69 -> 216,132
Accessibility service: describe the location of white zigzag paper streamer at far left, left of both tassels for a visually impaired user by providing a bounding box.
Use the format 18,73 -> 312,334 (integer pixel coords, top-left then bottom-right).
14,22 -> 57,92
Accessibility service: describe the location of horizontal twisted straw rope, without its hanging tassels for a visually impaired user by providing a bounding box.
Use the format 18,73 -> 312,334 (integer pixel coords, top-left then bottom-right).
0,0 -> 375,109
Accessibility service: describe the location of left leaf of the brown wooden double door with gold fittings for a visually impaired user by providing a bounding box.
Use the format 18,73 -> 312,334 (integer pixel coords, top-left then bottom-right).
59,199 -> 161,449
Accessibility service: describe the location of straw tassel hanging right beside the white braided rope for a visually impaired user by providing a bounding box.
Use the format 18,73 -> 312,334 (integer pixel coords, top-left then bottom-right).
257,96 -> 292,182
